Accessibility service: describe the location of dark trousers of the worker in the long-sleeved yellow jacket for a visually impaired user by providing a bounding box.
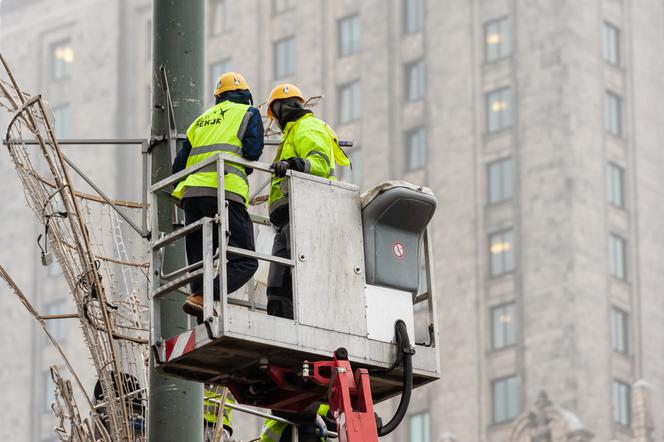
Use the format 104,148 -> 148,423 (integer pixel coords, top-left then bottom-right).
267,223 -> 293,319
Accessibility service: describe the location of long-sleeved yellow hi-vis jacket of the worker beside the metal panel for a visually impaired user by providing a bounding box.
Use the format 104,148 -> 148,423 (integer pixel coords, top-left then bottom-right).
268,114 -> 336,217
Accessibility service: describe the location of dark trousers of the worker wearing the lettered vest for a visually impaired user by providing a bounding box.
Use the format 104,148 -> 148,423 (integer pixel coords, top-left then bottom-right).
182,196 -> 258,300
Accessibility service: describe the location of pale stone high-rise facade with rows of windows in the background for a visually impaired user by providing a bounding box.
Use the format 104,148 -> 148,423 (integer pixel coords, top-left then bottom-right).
0,0 -> 664,442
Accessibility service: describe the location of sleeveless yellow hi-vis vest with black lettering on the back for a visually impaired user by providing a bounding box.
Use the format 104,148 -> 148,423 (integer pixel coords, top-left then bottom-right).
173,100 -> 251,204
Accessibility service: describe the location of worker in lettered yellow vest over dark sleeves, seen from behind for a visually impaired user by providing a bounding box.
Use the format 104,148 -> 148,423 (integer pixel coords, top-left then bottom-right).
173,72 -> 263,322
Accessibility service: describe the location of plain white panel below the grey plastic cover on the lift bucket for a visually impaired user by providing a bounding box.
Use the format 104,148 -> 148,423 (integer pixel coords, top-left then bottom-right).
364,285 -> 415,345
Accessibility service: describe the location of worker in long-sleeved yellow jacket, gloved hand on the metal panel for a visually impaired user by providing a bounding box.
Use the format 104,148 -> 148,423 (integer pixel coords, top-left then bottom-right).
267,84 -> 350,318
